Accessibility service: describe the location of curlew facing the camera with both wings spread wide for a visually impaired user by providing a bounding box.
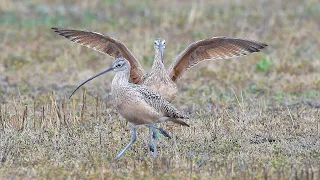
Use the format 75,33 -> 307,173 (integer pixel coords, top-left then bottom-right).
52,28 -> 267,148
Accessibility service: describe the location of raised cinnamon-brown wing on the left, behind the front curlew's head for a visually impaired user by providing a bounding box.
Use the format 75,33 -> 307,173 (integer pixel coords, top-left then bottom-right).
52,28 -> 145,84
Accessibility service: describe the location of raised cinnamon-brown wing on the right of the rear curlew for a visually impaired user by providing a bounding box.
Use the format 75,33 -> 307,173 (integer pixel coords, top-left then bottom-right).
169,37 -> 268,82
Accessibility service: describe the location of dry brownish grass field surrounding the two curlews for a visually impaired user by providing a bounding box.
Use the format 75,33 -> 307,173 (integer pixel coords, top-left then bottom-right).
0,0 -> 320,179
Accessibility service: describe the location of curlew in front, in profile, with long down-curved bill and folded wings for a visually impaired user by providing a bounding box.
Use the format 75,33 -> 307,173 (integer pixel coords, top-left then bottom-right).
71,57 -> 189,162
